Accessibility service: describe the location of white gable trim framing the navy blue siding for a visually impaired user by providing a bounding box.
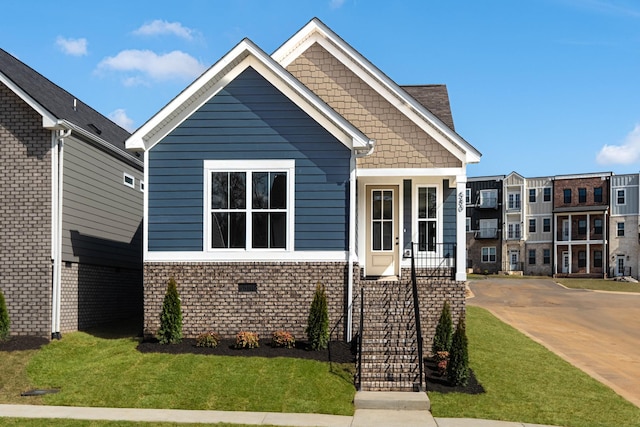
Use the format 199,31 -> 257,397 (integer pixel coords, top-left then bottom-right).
126,39 -> 371,151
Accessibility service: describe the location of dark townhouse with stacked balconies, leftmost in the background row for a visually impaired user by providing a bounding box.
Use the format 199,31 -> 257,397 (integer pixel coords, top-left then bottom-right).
465,175 -> 505,274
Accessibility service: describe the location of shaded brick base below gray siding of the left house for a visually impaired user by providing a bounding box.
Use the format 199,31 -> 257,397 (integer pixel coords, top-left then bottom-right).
60,262 -> 142,333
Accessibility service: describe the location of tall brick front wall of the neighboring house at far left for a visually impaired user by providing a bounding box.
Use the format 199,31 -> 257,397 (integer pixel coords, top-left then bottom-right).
0,84 -> 51,337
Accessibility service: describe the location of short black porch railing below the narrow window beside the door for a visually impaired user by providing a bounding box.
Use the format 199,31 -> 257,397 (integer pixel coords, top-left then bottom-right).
411,242 -> 457,280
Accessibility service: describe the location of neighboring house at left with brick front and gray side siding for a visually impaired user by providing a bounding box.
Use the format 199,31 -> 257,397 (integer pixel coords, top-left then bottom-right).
0,49 -> 143,337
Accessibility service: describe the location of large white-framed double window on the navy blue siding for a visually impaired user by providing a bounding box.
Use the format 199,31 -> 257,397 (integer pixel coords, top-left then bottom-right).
204,160 -> 295,251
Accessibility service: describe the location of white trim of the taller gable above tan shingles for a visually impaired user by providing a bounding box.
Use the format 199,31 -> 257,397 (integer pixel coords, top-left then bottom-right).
272,18 -> 481,163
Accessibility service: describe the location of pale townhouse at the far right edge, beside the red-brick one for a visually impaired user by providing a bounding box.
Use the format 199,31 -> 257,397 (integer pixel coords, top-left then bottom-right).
608,173 -> 640,279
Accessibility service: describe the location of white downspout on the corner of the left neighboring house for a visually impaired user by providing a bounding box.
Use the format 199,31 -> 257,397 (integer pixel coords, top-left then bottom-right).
51,129 -> 71,339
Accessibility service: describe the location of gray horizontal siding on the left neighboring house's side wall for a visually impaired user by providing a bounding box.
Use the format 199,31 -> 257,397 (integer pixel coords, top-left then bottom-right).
62,137 -> 143,269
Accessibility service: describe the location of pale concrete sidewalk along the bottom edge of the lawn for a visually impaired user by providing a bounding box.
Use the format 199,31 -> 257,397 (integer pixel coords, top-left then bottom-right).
0,405 -> 560,427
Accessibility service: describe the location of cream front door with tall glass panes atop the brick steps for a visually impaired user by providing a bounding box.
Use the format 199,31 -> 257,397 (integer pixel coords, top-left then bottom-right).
366,185 -> 400,276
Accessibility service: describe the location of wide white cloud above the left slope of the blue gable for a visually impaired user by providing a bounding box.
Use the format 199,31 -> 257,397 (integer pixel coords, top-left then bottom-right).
97,49 -> 206,86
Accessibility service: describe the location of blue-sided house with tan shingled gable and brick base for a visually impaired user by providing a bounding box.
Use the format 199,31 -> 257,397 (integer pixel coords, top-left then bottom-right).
127,19 -> 480,350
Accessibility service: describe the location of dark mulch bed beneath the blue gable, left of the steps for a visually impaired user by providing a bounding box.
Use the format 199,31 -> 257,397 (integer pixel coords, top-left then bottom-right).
138,338 -> 355,363
